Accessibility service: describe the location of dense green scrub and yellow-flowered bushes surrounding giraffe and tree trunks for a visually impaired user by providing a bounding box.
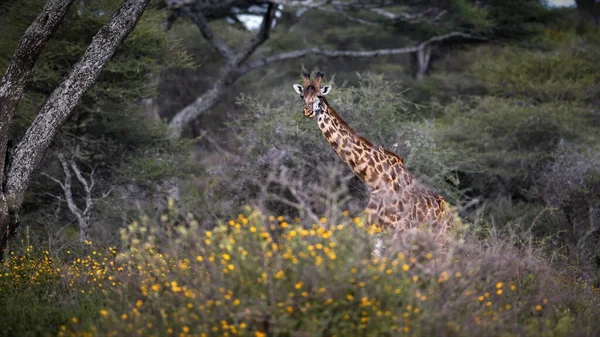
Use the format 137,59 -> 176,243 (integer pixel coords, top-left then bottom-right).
0,0 -> 600,337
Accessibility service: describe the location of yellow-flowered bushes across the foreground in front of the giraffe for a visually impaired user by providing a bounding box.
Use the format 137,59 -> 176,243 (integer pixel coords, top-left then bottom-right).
0,203 -> 600,336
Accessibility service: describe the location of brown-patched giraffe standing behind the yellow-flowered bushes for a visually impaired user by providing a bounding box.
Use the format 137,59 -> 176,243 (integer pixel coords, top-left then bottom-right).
294,72 -> 454,235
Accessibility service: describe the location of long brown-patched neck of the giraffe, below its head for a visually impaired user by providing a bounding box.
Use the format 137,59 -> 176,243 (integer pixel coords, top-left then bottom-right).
317,100 -> 413,192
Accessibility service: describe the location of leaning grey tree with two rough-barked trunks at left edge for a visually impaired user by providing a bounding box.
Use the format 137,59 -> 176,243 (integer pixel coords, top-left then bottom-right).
0,0 -> 150,258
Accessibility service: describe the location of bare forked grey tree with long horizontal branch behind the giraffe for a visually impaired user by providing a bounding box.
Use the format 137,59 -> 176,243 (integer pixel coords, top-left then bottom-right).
165,0 -> 483,135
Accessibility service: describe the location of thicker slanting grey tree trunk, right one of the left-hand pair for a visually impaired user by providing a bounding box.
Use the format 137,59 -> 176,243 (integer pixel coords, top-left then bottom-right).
0,0 -> 150,258
